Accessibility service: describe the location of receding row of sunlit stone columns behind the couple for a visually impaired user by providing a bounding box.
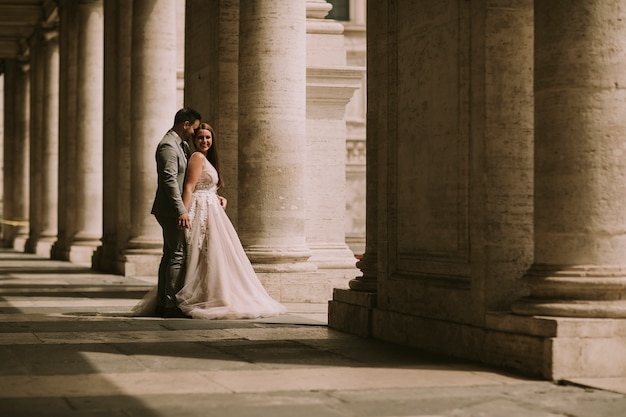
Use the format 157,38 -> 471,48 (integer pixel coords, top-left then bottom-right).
5,0 -> 363,301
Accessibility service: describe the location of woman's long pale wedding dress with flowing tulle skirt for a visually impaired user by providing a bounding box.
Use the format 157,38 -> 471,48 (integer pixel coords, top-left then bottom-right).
134,160 -> 287,319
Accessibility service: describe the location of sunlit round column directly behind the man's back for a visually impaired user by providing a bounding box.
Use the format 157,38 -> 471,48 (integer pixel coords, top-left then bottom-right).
125,0 -> 177,276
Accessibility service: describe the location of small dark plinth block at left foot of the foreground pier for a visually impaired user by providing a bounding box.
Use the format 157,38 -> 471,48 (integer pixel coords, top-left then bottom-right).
328,288 -> 376,337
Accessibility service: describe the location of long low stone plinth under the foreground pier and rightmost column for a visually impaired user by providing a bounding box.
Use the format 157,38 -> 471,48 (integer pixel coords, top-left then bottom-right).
356,306 -> 626,381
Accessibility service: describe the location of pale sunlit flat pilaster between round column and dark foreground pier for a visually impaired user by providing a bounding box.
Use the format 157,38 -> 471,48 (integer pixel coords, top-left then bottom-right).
305,0 -> 365,282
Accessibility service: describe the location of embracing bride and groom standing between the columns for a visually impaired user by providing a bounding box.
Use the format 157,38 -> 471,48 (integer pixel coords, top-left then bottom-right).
133,108 -> 287,319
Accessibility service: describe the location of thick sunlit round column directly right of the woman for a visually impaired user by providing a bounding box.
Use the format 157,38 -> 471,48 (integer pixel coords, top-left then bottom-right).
239,0 -> 315,272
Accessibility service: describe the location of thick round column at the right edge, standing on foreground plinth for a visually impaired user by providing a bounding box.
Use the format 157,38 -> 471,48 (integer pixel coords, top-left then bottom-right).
513,0 -> 626,318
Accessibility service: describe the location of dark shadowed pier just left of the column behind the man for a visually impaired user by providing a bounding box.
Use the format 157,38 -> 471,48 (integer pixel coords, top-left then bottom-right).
94,0 -> 132,274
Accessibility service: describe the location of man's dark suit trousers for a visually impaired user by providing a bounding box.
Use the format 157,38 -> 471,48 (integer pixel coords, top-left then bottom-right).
156,216 -> 187,311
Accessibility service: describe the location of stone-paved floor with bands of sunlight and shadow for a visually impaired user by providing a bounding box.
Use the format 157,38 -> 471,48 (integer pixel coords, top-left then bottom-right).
0,250 -> 626,417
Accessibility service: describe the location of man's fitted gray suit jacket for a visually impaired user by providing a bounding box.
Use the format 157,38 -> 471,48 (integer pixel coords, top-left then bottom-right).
152,130 -> 187,217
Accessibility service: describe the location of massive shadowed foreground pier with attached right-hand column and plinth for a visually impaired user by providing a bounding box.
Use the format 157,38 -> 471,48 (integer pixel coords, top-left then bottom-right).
329,0 -> 626,380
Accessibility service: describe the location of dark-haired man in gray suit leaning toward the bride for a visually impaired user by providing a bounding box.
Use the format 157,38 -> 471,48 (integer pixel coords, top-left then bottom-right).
152,108 -> 202,317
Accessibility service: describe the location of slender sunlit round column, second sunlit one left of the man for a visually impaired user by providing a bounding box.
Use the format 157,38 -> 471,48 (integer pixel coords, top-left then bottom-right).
69,0 -> 104,263
